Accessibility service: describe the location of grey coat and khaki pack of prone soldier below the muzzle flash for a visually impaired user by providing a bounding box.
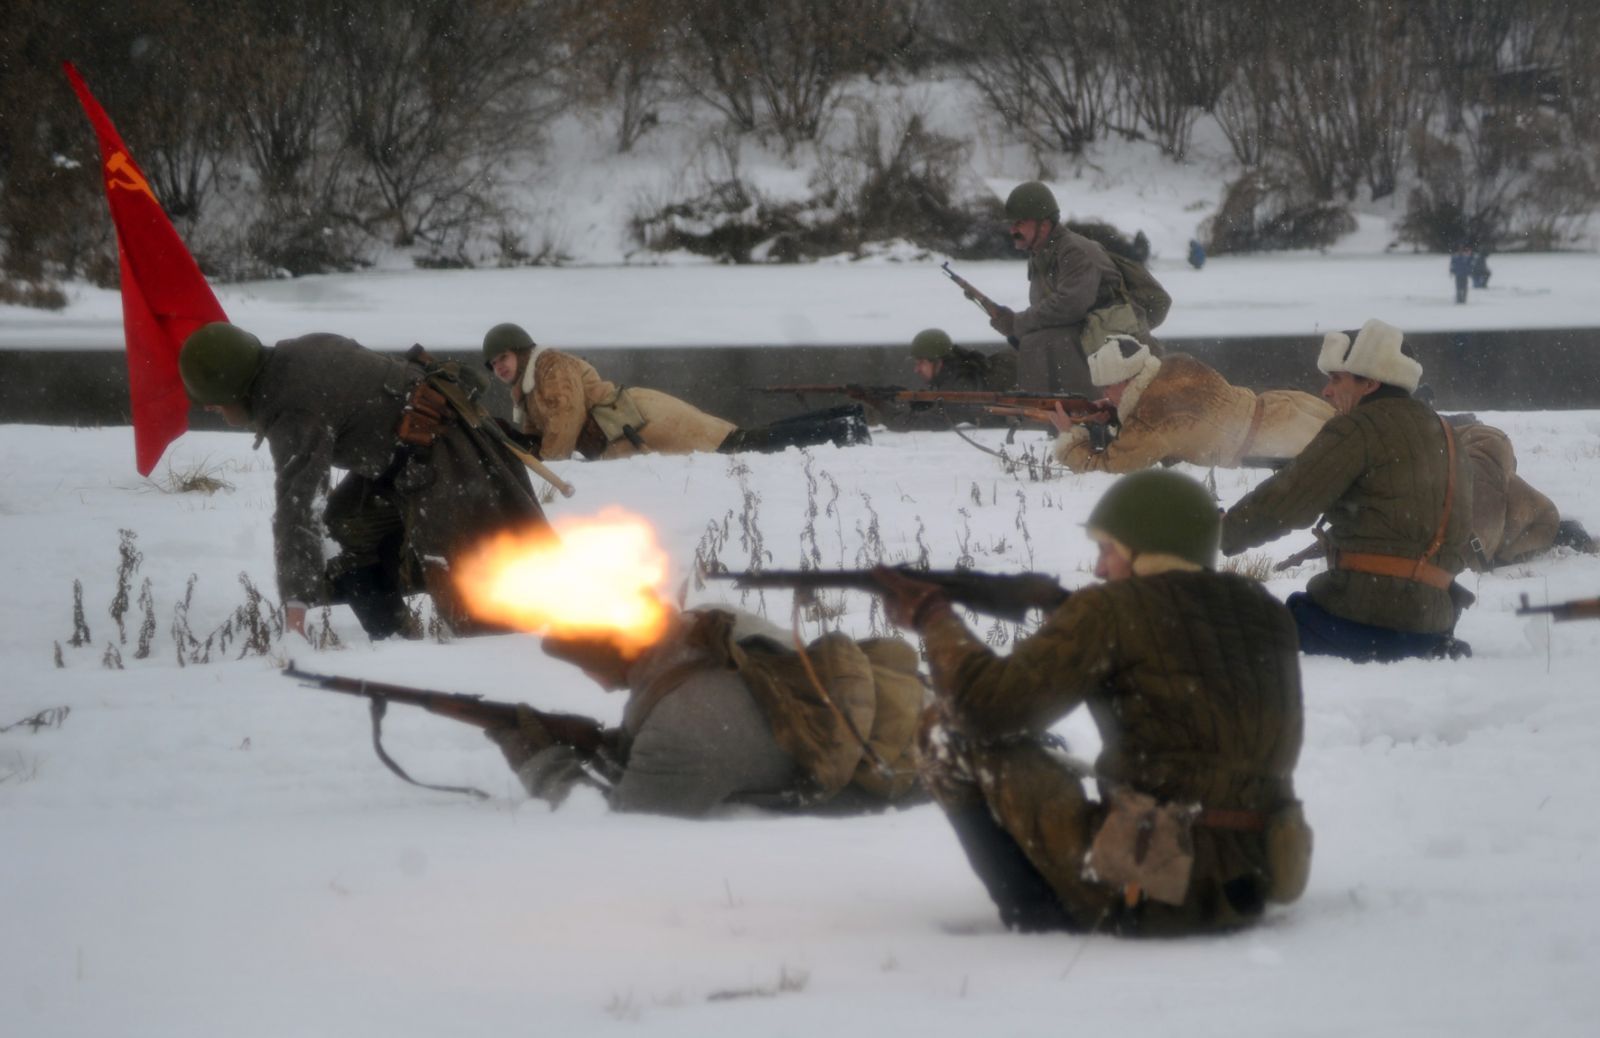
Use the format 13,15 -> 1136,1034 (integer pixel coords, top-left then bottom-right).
491,609 -> 926,817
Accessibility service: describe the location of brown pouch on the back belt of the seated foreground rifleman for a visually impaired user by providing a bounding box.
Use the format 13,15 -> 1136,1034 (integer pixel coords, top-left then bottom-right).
1083,785 -> 1198,905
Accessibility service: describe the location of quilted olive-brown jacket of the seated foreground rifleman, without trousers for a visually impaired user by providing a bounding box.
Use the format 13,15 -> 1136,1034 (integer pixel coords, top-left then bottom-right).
922,571 -> 1304,921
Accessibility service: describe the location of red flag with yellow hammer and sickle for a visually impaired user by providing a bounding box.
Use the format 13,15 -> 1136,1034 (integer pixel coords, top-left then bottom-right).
62,61 -> 227,475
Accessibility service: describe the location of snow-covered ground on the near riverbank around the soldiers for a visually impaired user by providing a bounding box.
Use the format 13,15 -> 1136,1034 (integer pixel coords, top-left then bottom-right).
0,415 -> 1600,1038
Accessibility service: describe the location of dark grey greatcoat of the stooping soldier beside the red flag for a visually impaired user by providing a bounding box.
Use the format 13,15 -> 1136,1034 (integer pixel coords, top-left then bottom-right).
246,334 -> 544,603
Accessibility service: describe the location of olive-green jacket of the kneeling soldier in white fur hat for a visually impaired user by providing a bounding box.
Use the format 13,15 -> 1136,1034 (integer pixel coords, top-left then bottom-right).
1222,387 -> 1472,633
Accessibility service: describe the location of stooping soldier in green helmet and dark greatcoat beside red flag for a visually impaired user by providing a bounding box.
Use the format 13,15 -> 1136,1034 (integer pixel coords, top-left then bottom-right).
178,321 -> 546,638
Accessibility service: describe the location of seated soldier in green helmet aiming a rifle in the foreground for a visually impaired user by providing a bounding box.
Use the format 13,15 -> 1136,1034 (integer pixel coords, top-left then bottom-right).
874,470 -> 1310,936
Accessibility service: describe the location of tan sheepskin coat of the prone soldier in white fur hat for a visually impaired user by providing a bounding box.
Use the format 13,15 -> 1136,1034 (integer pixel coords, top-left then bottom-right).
1054,353 -> 1333,472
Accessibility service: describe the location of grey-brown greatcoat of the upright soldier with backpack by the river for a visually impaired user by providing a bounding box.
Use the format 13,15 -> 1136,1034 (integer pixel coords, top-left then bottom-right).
1016,224 -> 1150,395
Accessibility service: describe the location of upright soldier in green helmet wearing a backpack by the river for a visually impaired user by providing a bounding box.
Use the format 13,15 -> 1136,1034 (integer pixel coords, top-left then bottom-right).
989,181 -> 1165,395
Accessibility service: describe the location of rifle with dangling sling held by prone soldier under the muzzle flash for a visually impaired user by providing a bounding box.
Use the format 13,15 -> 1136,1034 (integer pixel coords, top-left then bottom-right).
283,662 -> 613,800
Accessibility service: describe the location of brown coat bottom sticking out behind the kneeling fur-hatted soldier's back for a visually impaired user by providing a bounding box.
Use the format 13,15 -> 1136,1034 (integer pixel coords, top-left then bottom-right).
1456,422 -> 1562,569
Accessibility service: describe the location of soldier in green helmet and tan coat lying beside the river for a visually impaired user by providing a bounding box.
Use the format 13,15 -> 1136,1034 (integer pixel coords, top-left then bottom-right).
483,325 -> 872,461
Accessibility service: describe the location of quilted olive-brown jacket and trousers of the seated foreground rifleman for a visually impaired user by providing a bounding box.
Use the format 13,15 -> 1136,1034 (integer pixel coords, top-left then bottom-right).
923,571 -> 1309,934
